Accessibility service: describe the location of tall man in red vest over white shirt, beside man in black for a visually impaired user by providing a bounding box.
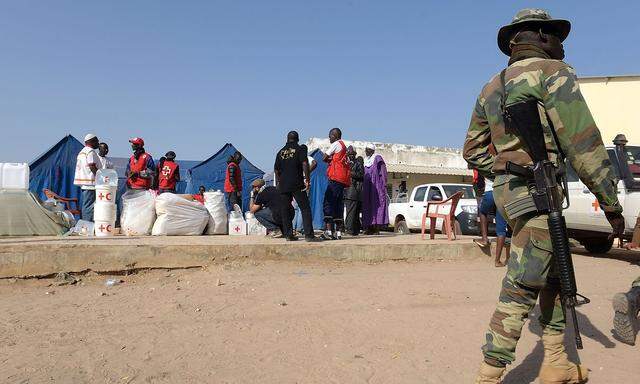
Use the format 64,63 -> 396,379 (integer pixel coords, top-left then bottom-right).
321,128 -> 351,240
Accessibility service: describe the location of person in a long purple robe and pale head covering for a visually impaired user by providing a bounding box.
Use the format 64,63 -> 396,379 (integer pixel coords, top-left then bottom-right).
362,144 -> 389,234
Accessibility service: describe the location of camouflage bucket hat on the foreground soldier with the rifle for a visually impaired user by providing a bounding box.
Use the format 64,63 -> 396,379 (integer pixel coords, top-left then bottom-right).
498,8 -> 571,56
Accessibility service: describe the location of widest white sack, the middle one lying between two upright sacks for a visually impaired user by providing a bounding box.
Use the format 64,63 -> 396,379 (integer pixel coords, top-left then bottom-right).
151,193 -> 209,236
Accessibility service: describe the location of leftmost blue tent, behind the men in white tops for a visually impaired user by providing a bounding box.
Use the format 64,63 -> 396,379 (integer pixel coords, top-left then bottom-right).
29,135 -> 84,199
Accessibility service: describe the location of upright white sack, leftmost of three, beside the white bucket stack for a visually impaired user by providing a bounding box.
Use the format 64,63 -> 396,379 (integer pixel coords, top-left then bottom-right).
120,190 -> 156,236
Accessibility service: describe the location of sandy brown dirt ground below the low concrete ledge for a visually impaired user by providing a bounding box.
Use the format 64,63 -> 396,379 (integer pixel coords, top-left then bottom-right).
0,252 -> 640,384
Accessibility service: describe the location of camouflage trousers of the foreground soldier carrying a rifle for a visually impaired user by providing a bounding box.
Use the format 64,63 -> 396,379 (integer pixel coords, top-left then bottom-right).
482,175 -> 565,366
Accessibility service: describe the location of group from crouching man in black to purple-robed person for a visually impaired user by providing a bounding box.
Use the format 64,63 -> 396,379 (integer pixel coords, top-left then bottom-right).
250,128 -> 389,241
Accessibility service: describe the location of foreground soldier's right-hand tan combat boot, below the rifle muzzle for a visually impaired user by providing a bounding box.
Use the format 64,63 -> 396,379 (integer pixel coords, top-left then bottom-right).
539,334 -> 589,384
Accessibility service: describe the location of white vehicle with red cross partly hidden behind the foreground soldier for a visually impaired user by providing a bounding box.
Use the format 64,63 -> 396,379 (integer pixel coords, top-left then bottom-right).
563,135 -> 640,253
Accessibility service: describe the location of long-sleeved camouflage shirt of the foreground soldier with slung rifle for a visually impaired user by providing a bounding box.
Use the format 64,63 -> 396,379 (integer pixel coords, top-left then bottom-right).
463,57 -> 622,212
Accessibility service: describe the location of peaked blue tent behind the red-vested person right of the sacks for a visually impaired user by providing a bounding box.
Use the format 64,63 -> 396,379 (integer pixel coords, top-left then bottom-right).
186,143 -> 264,210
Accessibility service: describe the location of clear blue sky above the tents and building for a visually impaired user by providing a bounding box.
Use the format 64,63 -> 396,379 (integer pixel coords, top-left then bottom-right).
0,0 -> 640,170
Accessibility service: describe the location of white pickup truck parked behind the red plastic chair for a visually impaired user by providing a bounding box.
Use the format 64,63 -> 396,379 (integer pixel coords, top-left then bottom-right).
389,184 -> 478,234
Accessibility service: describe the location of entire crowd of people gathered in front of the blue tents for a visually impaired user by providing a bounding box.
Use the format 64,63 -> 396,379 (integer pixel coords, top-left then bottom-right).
74,128 -> 389,241
